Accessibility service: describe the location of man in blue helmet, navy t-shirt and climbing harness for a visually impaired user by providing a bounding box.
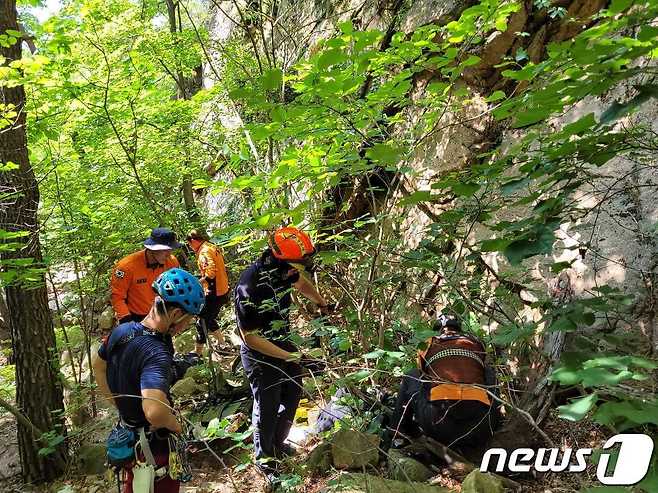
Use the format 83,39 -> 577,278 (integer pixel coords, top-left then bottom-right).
93,268 -> 204,493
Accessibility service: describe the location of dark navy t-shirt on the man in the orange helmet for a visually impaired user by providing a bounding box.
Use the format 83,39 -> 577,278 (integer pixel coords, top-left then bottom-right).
235,252 -> 299,344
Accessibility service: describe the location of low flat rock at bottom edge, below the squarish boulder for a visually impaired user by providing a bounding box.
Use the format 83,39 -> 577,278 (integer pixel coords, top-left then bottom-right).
323,473 -> 454,493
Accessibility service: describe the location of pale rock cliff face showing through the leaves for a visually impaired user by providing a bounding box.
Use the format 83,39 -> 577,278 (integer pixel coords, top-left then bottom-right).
205,0 -> 658,351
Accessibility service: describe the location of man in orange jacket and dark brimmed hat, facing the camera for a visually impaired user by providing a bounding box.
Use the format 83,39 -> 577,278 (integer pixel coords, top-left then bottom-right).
110,228 -> 182,324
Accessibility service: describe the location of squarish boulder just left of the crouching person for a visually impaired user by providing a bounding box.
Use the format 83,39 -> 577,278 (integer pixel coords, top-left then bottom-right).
331,429 -> 380,469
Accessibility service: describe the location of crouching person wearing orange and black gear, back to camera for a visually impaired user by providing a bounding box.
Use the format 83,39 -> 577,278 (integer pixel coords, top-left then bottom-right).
385,316 -> 500,452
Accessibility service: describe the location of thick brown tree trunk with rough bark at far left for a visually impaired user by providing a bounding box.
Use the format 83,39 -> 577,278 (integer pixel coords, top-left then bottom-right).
0,0 -> 66,482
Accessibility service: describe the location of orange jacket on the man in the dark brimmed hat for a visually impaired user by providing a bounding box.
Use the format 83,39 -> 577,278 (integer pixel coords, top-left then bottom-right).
110,250 -> 179,320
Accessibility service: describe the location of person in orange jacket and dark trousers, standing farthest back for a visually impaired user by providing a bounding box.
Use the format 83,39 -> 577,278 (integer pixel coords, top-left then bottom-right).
187,229 -> 229,355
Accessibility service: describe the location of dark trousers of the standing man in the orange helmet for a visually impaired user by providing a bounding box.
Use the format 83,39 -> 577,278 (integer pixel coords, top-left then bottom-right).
240,344 -> 303,459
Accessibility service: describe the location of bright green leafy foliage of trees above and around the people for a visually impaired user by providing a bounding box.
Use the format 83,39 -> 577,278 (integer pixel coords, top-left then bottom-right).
6,0 -> 658,487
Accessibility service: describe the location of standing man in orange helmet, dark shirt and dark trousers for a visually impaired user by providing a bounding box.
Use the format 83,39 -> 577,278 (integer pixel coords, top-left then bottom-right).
235,227 -> 328,482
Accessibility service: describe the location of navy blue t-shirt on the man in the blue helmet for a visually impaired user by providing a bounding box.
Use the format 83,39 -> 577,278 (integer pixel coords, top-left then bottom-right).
98,322 -> 174,426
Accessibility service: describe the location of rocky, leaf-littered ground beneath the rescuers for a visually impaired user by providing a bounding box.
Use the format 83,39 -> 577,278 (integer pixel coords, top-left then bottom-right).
0,400 -> 602,493
